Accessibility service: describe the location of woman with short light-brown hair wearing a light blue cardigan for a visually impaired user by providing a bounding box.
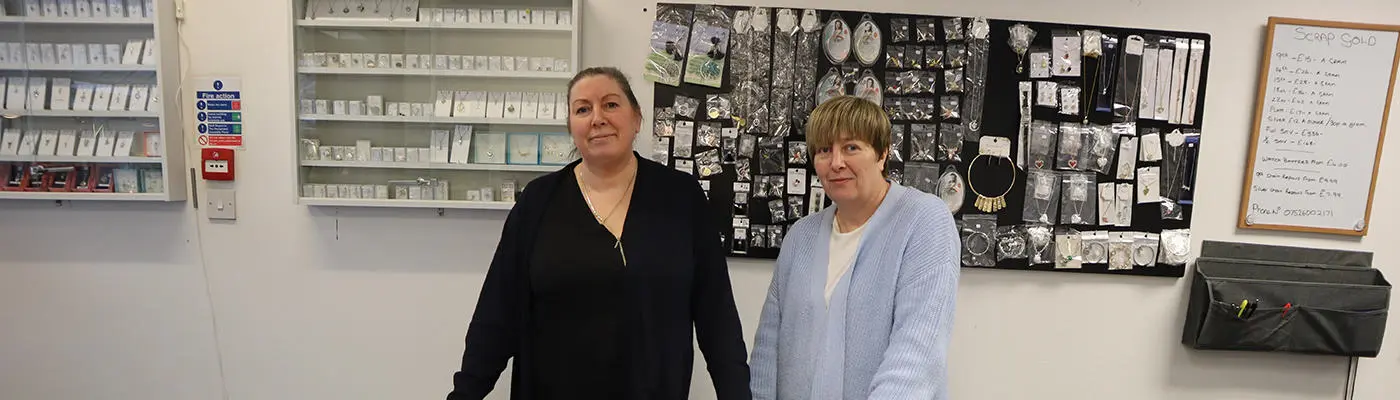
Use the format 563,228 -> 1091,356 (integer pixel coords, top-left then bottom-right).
750,97 -> 960,400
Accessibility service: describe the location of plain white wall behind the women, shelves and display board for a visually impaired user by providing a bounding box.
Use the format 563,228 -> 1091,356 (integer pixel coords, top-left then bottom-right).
0,0 -> 1400,400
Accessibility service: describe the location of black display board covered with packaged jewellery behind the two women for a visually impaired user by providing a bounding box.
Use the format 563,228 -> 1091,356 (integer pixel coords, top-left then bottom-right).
649,4 -> 1210,277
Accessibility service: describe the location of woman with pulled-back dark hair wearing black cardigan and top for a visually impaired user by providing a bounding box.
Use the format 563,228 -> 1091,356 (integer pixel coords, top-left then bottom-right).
448,67 -> 750,400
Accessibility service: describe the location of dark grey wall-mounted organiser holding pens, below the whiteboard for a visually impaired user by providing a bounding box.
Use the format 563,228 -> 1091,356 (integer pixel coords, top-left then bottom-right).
1182,241 -> 1390,358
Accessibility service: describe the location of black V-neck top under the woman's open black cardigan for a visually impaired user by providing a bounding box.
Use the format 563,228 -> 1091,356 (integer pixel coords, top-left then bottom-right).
529,173 -> 627,399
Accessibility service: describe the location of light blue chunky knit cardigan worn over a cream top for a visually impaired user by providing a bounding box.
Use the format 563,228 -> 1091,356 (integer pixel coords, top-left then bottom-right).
749,185 -> 960,400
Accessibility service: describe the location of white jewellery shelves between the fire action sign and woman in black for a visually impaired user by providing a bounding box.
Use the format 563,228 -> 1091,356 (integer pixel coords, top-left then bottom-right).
293,0 -> 581,210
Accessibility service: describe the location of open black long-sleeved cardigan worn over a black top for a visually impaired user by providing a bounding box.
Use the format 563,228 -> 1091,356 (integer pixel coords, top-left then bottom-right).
447,152 -> 752,400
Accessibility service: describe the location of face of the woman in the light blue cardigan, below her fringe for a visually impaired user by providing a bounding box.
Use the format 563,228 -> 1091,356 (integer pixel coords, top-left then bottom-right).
812,134 -> 886,206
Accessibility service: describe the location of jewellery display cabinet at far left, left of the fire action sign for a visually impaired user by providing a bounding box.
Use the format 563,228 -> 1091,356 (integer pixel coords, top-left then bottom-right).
0,0 -> 188,201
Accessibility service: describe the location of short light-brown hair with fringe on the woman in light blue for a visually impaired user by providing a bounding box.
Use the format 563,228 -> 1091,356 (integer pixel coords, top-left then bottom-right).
806,95 -> 890,157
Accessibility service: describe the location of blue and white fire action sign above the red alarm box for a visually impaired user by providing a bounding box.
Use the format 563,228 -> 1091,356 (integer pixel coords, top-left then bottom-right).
193,77 -> 244,148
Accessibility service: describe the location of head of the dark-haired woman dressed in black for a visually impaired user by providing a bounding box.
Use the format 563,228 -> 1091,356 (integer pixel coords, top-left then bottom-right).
568,76 -> 641,159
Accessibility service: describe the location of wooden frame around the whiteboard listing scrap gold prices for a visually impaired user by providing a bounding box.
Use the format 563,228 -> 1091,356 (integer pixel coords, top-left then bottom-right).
1236,17 -> 1400,236
